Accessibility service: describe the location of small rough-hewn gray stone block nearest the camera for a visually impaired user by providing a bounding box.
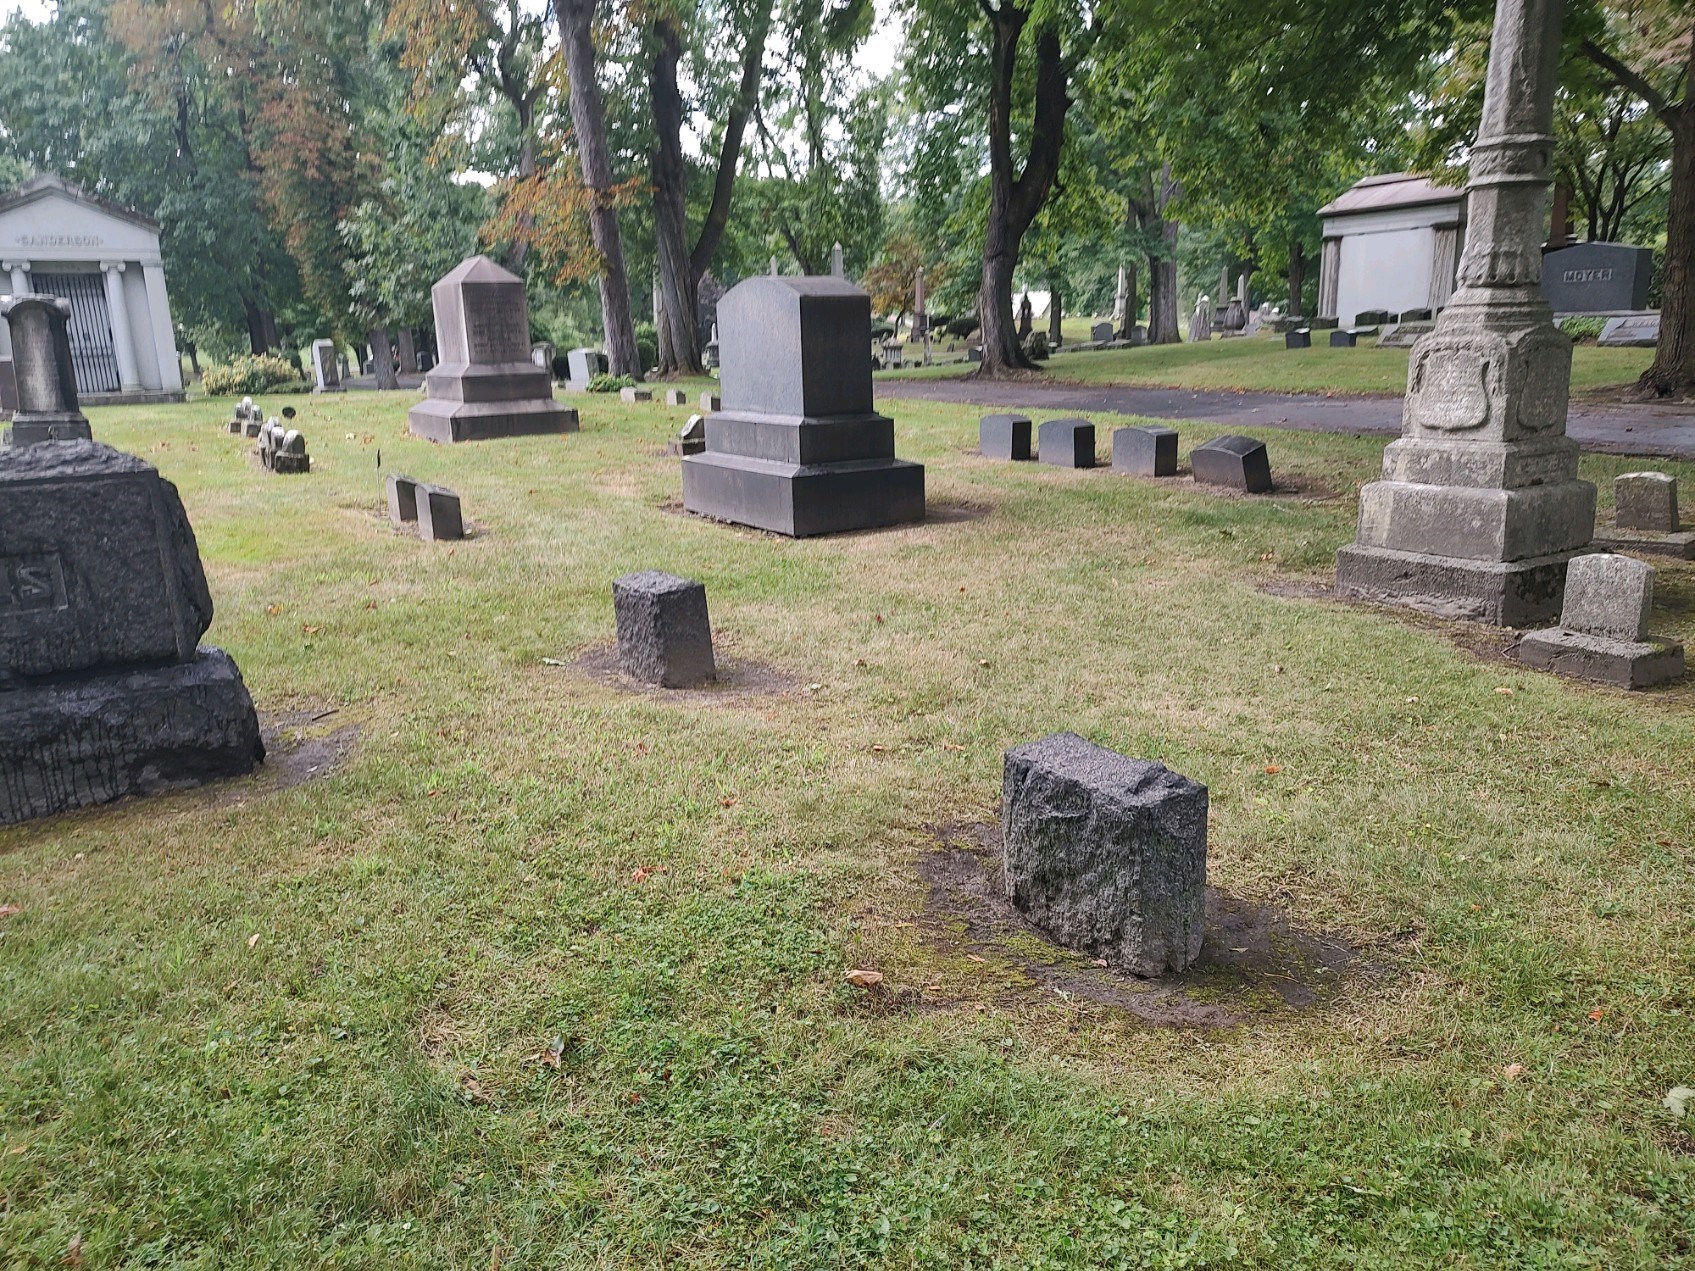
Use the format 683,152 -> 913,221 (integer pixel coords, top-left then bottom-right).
1000,732 -> 1207,976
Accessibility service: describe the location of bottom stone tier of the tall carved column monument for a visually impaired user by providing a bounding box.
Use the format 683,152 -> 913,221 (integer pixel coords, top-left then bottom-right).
1336,544 -> 1581,627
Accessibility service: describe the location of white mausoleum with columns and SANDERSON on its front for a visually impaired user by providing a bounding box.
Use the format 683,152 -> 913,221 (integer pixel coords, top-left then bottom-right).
0,176 -> 183,405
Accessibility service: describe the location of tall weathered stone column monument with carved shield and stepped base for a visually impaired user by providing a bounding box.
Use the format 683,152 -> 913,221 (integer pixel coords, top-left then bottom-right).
1336,0 -> 1595,627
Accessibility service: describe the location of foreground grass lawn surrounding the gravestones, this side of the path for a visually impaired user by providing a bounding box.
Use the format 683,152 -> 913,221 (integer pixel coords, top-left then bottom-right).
0,393 -> 1695,1269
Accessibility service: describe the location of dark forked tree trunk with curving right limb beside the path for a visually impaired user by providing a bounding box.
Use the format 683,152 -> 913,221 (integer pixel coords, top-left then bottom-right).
976,11 -> 1071,378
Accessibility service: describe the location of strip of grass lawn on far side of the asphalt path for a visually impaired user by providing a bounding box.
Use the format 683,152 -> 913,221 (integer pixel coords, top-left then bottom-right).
880,330 -> 1654,393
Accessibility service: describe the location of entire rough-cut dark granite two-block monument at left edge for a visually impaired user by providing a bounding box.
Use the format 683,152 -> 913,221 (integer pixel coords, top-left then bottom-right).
0,441 -> 264,824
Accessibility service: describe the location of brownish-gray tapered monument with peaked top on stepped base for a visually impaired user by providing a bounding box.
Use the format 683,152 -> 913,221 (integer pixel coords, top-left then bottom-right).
407,256 -> 576,442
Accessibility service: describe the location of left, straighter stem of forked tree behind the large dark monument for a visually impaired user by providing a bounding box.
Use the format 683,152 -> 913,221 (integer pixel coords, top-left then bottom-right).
647,10 -> 702,375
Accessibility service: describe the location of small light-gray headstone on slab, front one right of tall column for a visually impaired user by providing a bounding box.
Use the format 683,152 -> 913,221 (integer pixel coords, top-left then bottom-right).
1519,554 -> 1683,688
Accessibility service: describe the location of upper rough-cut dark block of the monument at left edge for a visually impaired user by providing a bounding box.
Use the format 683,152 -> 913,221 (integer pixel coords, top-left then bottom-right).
0,441 -> 212,688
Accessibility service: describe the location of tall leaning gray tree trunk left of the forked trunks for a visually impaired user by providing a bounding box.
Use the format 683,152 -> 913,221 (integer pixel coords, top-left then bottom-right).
553,0 -> 641,380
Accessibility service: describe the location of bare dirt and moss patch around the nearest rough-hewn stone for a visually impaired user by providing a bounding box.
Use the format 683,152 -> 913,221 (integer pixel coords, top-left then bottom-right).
917,824 -> 1371,1029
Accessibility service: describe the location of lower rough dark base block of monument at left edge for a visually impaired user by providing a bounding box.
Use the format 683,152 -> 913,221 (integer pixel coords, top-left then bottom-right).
0,646 -> 264,825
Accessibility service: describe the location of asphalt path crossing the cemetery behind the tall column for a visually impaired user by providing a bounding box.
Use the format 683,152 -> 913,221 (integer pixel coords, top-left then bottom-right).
876,378 -> 1695,459
